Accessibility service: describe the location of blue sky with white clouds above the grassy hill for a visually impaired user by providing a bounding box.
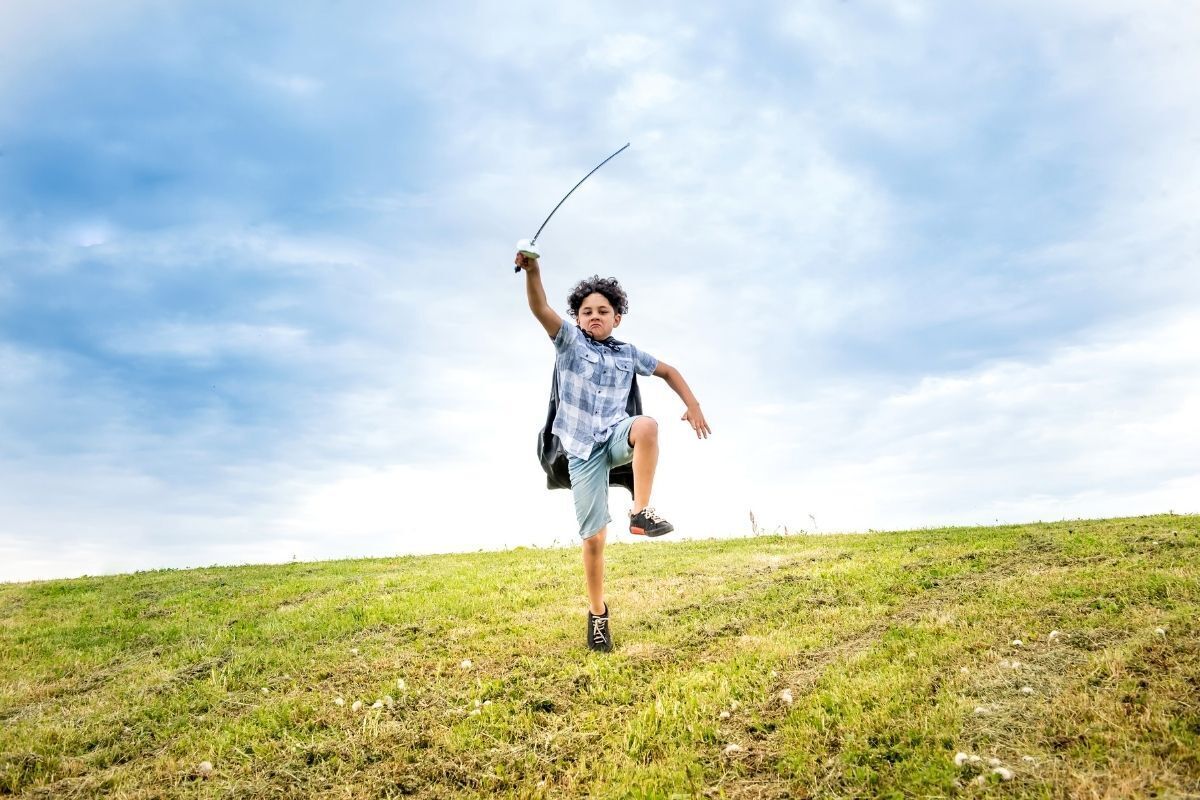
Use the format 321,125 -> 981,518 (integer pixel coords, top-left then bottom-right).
0,0 -> 1200,585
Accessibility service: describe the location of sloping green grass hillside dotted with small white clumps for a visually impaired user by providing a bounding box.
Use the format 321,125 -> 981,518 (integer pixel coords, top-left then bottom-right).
0,516 -> 1200,798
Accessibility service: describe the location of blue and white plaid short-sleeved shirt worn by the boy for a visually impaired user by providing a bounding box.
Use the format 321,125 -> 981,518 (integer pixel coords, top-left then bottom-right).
551,319 -> 659,459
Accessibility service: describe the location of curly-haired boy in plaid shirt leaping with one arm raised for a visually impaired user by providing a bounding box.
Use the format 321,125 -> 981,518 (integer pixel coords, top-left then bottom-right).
515,253 -> 712,652
